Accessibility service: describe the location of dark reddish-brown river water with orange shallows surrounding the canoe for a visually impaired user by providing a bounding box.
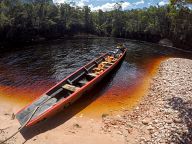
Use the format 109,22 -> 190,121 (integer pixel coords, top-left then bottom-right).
0,38 -> 191,114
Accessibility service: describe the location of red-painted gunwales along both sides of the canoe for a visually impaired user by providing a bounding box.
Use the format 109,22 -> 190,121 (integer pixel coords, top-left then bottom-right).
16,49 -> 127,127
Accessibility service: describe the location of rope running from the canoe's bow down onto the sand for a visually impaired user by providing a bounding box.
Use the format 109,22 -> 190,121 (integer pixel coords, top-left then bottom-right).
0,106 -> 40,144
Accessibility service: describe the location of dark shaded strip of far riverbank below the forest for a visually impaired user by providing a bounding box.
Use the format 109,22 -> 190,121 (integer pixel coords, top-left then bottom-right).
0,33 -> 192,53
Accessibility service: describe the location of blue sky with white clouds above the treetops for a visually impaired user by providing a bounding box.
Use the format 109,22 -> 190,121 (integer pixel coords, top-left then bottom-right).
53,0 -> 169,11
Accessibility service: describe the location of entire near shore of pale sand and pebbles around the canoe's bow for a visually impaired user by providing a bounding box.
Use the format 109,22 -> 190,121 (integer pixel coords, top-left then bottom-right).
0,58 -> 192,144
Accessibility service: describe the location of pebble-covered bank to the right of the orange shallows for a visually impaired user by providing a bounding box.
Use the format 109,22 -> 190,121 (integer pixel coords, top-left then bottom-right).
103,58 -> 192,144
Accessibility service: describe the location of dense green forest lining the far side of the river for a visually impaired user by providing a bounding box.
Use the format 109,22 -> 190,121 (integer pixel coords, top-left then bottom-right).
0,0 -> 192,49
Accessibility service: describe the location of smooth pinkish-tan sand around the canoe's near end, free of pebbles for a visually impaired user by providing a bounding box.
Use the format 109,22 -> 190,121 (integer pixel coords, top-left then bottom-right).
0,102 -> 124,144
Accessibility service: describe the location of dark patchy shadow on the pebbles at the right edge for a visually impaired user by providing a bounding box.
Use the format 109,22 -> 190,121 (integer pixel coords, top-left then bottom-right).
168,97 -> 192,144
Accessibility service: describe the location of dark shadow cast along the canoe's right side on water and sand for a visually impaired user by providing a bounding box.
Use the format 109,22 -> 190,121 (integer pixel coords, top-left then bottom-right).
21,61 -> 122,143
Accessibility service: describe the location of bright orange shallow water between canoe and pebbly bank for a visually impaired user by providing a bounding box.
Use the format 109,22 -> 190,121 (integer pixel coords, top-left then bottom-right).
76,57 -> 166,116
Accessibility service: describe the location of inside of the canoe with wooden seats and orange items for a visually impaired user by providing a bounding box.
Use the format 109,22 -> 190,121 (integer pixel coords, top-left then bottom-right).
16,49 -> 123,125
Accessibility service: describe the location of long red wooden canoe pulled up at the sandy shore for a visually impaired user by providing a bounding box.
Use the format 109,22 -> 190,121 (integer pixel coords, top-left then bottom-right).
16,48 -> 127,127
